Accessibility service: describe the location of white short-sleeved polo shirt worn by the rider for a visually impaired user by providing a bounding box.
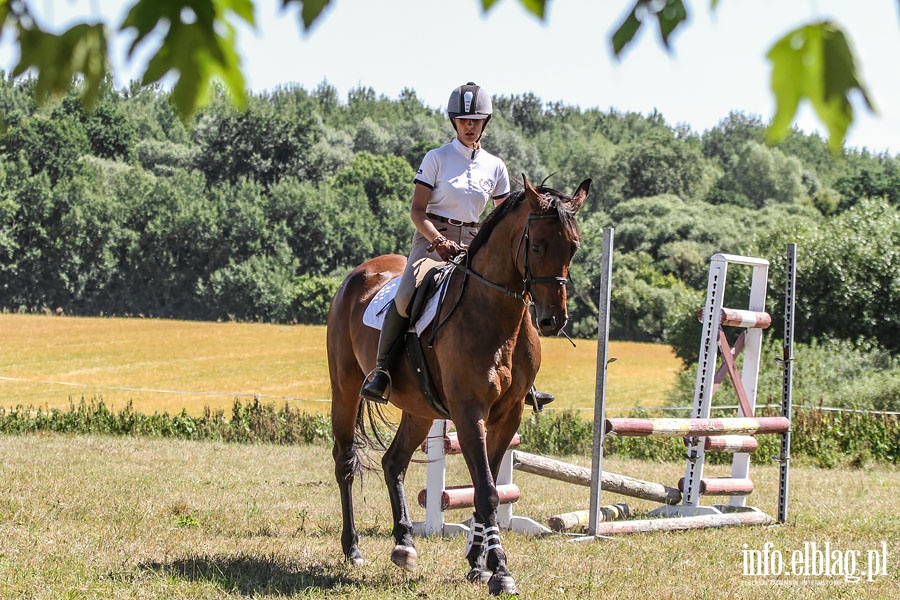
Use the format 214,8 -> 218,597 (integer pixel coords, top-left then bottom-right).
415,138 -> 510,223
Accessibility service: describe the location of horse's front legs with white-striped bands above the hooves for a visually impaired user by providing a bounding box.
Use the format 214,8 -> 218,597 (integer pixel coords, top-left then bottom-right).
456,419 -> 516,595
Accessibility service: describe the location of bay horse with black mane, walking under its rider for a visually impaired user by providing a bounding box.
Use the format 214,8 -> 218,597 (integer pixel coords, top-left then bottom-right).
327,178 -> 591,595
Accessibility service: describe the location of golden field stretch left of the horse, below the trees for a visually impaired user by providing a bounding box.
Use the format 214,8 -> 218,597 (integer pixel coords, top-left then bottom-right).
0,315 -> 329,414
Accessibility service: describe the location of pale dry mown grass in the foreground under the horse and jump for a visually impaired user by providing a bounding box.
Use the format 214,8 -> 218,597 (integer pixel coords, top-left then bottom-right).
0,435 -> 900,600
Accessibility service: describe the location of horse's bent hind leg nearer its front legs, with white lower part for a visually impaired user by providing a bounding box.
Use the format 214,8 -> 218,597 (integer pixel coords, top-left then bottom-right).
381,413 -> 432,571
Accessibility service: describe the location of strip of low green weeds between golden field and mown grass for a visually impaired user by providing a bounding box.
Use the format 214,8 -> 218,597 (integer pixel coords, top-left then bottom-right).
0,398 -> 900,468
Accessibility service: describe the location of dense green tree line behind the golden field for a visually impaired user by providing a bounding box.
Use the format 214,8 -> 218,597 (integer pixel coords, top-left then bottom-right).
0,75 -> 900,363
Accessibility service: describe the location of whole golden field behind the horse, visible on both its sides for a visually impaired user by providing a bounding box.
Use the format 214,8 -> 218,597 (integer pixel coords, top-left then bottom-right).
0,314 -> 680,414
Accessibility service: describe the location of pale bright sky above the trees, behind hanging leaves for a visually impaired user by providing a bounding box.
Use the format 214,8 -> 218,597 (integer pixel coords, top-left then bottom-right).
0,0 -> 900,155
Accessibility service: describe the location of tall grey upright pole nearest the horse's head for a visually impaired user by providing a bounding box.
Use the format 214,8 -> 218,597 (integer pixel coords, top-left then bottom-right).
588,227 -> 615,536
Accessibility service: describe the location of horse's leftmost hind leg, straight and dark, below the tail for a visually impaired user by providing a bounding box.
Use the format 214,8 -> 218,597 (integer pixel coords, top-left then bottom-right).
331,374 -> 364,565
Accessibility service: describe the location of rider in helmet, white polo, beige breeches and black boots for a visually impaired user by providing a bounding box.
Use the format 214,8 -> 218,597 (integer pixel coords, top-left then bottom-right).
360,81 -> 554,411
